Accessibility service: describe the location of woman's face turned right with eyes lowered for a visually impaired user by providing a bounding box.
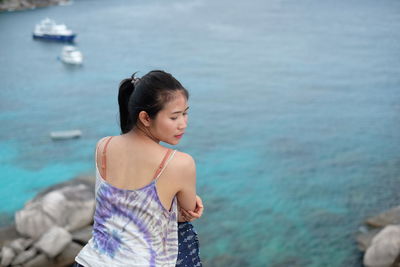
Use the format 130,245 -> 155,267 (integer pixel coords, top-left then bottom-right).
151,92 -> 189,145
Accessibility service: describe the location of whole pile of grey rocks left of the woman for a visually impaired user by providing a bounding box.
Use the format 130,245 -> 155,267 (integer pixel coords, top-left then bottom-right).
0,177 -> 95,267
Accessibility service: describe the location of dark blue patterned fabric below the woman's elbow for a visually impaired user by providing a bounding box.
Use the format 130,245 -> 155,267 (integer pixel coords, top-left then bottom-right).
176,222 -> 202,267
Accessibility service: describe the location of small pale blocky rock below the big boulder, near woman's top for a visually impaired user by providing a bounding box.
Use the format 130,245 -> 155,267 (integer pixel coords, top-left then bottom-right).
34,226 -> 72,258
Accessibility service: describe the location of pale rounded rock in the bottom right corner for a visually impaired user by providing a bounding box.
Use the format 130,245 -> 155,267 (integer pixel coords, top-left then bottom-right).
363,225 -> 400,267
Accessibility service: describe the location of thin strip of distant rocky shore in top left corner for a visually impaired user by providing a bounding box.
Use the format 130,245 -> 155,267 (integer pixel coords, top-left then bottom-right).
0,0 -> 70,12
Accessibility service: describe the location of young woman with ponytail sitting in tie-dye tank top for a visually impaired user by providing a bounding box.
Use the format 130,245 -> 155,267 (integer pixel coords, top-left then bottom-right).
73,70 -> 203,267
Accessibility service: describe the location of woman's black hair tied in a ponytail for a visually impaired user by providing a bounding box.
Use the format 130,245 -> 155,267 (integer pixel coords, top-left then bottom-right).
118,70 -> 189,134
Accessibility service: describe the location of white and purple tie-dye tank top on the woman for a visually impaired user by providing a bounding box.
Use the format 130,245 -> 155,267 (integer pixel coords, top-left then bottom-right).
75,136 -> 178,267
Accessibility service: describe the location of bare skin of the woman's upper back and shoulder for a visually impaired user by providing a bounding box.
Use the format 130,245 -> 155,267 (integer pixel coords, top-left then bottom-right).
96,134 -> 186,213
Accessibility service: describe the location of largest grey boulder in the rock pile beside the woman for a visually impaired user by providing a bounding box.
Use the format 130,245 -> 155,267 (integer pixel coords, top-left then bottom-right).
15,178 -> 95,238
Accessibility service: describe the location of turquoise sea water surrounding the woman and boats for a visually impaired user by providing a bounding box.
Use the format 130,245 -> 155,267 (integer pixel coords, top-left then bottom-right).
0,0 -> 400,267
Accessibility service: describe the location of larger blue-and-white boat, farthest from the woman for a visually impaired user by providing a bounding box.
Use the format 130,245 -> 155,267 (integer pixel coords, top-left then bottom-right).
33,18 -> 76,42
